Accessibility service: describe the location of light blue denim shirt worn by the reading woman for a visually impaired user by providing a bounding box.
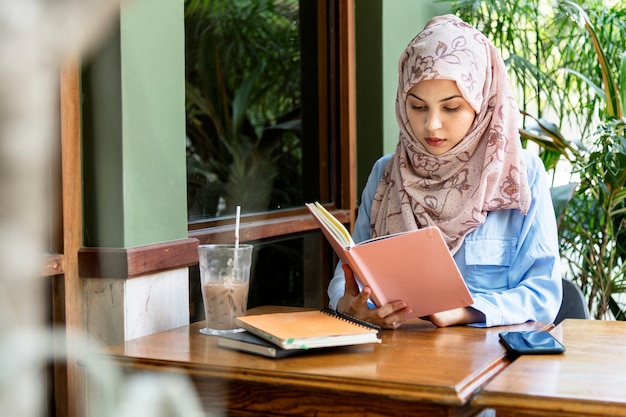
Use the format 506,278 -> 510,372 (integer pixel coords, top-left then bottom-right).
328,151 -> 562,326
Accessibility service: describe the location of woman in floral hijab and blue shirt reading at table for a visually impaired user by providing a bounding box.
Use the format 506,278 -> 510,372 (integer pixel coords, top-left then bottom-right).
328,15 -> 562,328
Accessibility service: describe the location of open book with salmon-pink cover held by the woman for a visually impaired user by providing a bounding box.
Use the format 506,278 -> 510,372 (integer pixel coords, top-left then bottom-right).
306,202 -> 474,318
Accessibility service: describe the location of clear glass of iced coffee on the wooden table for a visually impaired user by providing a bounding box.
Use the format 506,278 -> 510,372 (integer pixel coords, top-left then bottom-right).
198,244 -> 253,335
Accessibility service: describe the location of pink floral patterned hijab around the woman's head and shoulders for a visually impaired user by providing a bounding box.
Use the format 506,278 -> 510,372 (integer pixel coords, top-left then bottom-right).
370,15 -> 531,254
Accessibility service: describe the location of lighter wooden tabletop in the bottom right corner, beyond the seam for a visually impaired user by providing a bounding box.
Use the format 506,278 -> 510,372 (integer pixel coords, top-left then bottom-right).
472,319 -> 626,417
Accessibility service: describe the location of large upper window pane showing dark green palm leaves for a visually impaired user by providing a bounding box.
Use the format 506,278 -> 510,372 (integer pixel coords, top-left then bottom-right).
185,0 -> 303,221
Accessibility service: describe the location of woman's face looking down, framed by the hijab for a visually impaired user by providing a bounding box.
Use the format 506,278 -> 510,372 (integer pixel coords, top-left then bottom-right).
406,80 -> 476,155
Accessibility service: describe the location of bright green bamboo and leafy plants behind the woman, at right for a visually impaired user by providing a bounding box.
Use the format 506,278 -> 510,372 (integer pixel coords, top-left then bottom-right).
444,0 -> 626,320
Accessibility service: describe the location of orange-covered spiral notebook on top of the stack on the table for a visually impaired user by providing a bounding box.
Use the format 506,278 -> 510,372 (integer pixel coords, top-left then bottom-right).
237,309 -> 382,349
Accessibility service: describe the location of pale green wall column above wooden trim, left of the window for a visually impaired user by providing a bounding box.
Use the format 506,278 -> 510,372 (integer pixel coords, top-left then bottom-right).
83,0 -> 187,247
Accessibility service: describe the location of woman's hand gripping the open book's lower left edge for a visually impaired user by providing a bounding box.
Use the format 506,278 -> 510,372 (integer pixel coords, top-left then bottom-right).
337,264 -> 413,329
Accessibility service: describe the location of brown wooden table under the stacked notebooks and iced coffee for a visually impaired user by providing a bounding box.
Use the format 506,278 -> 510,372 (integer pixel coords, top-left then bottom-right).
108,309 -> 545,417
